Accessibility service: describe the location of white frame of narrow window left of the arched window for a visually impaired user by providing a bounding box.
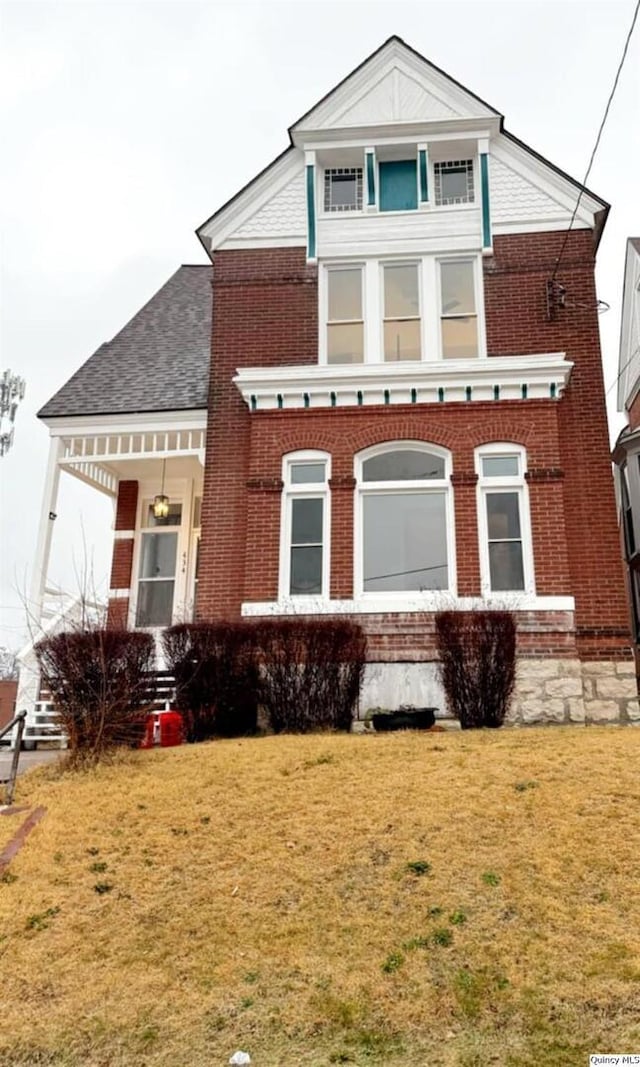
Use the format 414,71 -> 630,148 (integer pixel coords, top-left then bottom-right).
278,449 -> 331,607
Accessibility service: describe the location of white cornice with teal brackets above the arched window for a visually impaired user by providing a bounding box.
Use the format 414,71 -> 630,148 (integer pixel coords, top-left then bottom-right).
234,352 -> 573,412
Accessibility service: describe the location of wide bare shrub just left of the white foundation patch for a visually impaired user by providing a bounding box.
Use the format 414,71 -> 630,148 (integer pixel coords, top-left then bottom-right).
253,619 -> 367,733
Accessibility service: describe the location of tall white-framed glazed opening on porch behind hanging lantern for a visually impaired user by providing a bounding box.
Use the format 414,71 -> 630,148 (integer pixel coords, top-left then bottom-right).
135,501 -> 182,626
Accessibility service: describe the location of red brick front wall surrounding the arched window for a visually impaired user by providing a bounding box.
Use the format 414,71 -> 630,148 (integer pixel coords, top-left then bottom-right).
190,230 -> 629,659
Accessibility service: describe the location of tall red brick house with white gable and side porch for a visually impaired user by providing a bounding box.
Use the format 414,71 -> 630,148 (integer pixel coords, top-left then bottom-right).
22,37 -> 638,722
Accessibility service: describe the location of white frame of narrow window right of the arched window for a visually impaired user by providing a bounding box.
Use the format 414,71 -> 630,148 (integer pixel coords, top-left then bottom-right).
475,442 -> 535,603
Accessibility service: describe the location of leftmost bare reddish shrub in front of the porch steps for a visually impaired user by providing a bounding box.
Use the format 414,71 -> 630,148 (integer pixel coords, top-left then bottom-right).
35,627 -> 156,764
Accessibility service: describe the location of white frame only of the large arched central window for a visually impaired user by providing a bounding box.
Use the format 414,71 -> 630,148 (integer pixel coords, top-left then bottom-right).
353,440 -> 458,610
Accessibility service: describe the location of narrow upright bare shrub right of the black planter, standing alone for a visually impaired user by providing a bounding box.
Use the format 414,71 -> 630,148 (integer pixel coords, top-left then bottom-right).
435,611 -> 515,730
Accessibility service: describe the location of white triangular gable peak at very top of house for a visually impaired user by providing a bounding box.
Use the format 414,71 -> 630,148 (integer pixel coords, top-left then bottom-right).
289,37 -> 500,144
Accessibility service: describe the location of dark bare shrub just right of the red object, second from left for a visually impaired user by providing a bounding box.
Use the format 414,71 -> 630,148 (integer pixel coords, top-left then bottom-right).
162,622 -> 258,742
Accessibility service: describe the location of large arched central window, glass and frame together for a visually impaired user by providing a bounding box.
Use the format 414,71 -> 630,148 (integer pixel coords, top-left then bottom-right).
355,442 -> 453,593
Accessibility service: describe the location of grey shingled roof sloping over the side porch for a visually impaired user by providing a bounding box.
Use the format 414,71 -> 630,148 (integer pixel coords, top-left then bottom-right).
38,264 -> 212,418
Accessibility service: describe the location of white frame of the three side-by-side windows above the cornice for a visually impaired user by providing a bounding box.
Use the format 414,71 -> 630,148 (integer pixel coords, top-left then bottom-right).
318,251 -> 486,372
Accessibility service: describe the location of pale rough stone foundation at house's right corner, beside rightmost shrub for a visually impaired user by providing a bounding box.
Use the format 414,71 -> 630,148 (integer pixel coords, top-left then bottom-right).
508,659 -> 640,723
